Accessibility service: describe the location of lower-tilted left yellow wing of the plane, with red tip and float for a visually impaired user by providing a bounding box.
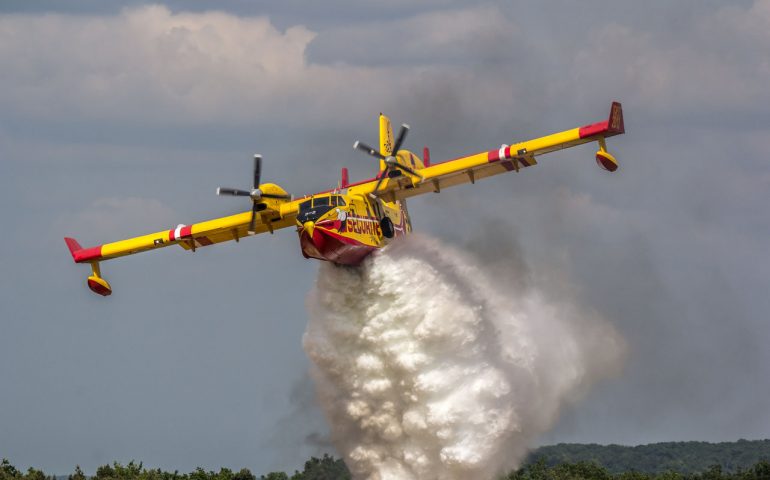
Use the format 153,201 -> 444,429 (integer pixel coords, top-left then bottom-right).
64,201 -> 299,296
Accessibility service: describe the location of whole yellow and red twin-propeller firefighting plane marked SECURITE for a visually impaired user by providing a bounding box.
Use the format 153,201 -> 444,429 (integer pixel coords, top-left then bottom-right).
64,102 -> 625,296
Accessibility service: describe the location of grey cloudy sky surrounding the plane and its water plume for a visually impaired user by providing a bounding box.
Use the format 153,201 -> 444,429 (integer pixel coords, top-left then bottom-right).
0,0 -> 770,473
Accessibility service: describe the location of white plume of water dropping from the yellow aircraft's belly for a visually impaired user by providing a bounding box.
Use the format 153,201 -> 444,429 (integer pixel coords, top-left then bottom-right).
304,235 -> 625,480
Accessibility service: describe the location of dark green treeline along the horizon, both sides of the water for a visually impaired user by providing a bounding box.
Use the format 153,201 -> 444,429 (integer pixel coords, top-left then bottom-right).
0,440 -> 770,480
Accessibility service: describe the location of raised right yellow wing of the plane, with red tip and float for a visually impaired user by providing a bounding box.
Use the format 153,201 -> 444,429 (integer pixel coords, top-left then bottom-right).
359,102 -> 625,200
